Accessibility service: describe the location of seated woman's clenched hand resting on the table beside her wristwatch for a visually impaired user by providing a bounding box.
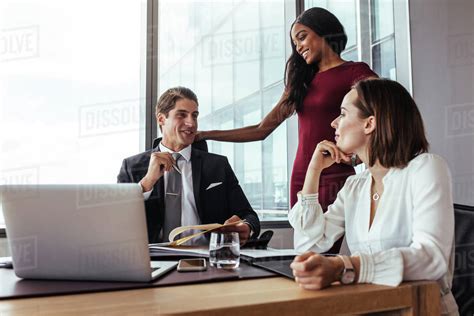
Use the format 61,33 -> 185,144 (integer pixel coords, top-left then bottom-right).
290,251 -> 344,290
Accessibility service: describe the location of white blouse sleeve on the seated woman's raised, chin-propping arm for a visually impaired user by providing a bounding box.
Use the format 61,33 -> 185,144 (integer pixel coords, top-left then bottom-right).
288,186 -> 345,253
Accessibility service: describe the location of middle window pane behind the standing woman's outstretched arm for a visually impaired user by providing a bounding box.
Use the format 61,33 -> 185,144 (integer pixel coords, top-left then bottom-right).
158,0 -> 295,220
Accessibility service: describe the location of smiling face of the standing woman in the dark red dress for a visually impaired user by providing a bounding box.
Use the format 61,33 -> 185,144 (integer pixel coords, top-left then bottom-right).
291,23 -> 325,65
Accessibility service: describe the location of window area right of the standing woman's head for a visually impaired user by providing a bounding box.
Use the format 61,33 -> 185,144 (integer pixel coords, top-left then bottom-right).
305,0 -> 410,82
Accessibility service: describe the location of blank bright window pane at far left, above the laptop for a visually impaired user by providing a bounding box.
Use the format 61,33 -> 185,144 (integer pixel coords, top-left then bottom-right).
0,0 -> 147,225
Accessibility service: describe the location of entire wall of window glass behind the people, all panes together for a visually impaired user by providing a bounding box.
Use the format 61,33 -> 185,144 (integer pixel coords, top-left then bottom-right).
0,0 -> 410,226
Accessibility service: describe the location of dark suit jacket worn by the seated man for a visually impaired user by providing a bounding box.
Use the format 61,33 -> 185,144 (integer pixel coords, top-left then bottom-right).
117,146 -> 260,243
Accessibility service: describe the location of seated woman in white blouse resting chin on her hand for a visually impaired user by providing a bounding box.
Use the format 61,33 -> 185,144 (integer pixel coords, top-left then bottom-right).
289,79 -> 457,315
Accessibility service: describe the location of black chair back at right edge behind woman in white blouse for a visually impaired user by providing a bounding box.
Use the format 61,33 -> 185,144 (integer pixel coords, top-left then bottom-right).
452,204 -> 474,315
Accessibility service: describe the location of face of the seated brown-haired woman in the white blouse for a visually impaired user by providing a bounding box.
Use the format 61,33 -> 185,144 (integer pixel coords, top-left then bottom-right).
331,89 -> 375,157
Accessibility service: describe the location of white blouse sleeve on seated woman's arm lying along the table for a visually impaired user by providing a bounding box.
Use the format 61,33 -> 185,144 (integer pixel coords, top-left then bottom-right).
354,154 -> 454,286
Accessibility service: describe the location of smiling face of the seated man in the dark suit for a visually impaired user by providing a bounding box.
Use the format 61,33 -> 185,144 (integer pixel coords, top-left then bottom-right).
157,98 -> 199,151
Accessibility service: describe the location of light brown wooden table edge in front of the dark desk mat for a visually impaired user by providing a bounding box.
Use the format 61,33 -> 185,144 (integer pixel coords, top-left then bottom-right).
0,277 -> 440,316
